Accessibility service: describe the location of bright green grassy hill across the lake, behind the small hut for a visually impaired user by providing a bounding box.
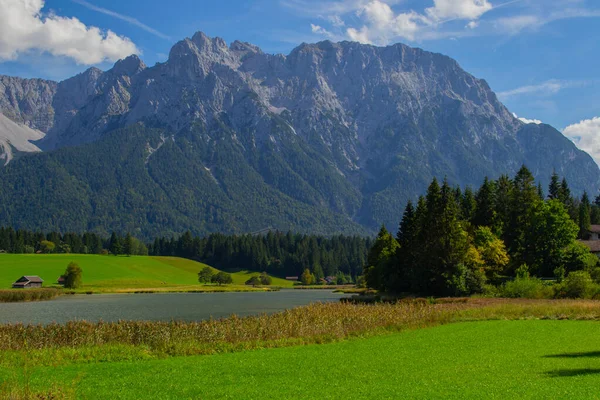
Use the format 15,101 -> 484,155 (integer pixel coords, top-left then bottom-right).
0,254 -> 292,291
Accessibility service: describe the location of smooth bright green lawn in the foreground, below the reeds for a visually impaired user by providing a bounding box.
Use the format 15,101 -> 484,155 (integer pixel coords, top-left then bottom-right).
0,320 -> 600,399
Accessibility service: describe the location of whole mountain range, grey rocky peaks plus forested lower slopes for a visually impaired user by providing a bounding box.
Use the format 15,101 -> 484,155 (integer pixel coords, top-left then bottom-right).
0,32 -> 600,238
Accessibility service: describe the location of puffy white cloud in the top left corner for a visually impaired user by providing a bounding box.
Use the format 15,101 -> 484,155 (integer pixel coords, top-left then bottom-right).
0,0 -> 140,65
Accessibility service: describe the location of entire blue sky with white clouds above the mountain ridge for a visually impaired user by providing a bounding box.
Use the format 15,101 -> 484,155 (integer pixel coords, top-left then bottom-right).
0,0 -> 600,164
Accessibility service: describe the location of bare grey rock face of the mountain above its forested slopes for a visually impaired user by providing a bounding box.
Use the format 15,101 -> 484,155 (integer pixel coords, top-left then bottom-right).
0,32 -> 600,233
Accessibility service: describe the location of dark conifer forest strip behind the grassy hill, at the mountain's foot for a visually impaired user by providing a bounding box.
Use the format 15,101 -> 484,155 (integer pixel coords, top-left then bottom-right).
0,228 -> 372,283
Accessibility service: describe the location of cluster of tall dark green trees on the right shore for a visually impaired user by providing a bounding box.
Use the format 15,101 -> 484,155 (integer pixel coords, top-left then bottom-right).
365,167 -> 600,295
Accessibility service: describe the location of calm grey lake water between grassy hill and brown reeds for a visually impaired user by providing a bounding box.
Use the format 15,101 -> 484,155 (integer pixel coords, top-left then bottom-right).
0,290 -> 348,324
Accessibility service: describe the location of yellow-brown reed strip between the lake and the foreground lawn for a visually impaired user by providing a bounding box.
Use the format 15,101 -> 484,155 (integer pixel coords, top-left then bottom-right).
0,299 -> 600,354
